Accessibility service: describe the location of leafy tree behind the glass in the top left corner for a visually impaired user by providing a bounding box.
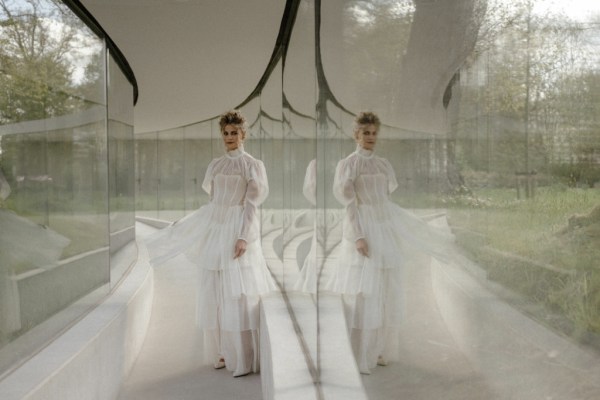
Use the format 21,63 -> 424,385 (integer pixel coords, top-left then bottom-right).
0,0 -> 94,124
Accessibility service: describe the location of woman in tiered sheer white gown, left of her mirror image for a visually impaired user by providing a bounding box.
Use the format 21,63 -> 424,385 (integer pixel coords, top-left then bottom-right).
147,110 -> 275,377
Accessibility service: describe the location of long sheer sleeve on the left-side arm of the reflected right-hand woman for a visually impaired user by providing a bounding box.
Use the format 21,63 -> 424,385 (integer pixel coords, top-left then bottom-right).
333,160 -> 365,240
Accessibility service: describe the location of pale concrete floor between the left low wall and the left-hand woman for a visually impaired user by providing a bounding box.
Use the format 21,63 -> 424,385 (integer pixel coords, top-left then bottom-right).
119,224 -> 262,400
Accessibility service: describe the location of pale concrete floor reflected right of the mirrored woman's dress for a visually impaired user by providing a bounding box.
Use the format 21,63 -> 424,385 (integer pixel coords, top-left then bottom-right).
356,218 -> 600,400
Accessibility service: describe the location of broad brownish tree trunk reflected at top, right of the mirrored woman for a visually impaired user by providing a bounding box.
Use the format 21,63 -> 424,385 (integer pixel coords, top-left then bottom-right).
396,0 -> 486,134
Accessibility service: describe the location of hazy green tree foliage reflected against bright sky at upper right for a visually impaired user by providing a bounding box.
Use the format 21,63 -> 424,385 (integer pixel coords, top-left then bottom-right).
453,0 -> 600,186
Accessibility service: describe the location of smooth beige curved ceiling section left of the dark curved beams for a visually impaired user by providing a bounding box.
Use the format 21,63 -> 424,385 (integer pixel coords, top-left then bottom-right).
81,0 -> 285,133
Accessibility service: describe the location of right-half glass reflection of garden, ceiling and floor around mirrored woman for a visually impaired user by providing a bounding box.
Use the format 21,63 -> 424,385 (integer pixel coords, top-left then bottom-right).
317,0 -> 600,398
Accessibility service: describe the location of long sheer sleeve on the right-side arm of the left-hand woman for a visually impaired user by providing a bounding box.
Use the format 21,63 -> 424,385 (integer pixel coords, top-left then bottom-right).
239,160 -> 269,242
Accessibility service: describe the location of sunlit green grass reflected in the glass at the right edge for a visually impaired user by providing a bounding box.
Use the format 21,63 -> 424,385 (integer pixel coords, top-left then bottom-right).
448,187 -> 600,269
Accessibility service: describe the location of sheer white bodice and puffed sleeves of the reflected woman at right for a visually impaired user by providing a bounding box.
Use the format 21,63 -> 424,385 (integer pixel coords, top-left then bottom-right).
333,147 -> 398,240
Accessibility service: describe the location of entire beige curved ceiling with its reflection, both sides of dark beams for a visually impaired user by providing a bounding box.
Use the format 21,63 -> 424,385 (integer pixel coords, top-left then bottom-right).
81,0 -> 480,134
